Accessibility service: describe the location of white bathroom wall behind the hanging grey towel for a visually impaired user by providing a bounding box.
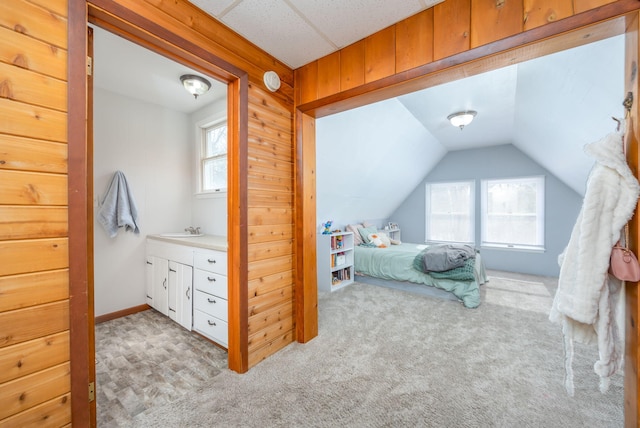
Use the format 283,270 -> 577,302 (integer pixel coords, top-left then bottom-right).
94,88 -> 192,315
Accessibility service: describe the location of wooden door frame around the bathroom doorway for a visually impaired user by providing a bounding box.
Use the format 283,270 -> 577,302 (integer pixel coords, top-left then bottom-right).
67,0 -> 249,426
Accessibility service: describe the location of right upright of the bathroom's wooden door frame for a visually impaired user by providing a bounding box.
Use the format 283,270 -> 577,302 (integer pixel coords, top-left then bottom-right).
227,75 -> 249,373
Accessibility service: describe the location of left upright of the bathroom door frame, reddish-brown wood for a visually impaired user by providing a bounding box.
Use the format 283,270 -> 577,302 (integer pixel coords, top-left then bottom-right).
67,0 -> 95,426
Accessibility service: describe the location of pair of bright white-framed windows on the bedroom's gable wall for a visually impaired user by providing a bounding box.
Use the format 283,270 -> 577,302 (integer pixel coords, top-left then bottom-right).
425,177 -> 544,250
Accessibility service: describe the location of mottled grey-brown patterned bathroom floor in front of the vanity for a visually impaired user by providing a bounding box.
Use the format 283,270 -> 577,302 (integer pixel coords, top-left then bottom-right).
95,309 -> 227,428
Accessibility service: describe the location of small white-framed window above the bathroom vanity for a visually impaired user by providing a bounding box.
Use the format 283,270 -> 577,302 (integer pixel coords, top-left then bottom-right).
200,121 -> 227,193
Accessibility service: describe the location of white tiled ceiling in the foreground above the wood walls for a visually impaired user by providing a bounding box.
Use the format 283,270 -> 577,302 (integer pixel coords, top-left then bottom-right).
190,0 -> 443,69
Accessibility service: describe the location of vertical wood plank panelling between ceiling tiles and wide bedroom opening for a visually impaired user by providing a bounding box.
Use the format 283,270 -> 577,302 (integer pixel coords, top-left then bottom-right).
295,0 -> 614,106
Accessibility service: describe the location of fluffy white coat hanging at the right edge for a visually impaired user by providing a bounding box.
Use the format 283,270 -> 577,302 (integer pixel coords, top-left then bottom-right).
549,132 -> 640,395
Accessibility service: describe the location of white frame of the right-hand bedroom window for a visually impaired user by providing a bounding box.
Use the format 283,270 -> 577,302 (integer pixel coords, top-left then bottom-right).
480,175 -> 546,252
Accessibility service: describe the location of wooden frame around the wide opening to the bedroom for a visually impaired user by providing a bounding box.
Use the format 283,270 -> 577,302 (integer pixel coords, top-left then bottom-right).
295,4 -> 640,427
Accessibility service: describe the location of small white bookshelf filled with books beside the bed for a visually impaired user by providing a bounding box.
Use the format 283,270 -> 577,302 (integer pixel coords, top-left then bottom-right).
316,232 -> 354,291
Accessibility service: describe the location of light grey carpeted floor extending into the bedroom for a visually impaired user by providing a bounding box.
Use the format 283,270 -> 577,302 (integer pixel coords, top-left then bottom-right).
98,272 -> 623,428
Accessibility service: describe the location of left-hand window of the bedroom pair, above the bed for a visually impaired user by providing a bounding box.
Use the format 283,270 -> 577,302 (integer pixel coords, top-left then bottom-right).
425,181 -> 475,243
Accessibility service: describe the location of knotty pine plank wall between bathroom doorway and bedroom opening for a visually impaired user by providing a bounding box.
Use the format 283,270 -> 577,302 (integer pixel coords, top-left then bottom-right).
243,84 -> 295,367
